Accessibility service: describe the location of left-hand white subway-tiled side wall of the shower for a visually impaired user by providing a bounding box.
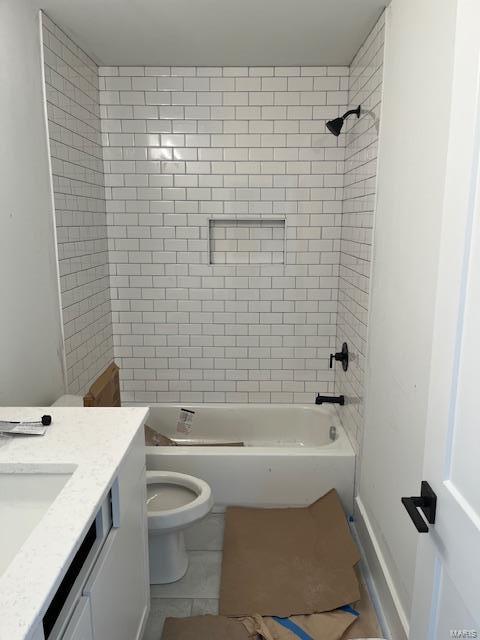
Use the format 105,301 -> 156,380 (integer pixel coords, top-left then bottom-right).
42,15 -> 113,393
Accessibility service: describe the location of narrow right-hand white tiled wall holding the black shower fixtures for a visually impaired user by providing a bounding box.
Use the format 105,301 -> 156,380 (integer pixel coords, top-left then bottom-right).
335,15 -> 385,451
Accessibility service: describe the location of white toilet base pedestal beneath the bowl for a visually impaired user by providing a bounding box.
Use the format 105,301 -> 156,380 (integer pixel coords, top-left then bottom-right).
148,531 -> 188,584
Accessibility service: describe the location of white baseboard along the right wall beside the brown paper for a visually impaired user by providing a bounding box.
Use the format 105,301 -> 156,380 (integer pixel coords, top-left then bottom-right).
355,496 -> 409,640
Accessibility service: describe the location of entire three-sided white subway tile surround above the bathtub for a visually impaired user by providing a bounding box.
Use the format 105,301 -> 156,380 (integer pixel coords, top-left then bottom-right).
43,16 -> 384,412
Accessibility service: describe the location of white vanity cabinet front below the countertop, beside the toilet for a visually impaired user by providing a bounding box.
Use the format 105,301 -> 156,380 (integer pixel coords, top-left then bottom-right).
28,428 -> 150,640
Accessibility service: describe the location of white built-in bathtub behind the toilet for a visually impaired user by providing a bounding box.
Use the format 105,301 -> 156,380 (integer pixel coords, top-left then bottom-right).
146,404 -> 355,514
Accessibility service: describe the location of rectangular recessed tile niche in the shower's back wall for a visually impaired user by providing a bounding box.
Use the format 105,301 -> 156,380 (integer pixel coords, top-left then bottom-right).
209,218 -> 285,264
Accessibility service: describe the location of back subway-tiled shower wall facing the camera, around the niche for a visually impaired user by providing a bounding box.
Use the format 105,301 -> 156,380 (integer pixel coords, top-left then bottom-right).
99,67 -> 349,403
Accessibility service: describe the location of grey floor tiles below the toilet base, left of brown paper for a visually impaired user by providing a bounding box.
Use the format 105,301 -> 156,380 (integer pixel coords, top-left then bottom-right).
143,551 -> 222,640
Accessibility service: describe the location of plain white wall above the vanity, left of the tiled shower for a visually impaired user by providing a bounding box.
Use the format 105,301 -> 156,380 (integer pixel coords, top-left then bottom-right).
0,0 -> 64,405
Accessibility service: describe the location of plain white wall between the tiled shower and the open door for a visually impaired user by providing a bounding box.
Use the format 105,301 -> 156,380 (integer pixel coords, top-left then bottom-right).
358,0 -> 456,632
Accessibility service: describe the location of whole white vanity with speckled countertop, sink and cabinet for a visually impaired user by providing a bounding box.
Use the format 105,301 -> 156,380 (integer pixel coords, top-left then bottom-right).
0,407 -> 150,640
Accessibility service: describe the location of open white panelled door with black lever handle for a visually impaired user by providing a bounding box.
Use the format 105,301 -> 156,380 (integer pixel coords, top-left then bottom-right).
405,0 -> 480,640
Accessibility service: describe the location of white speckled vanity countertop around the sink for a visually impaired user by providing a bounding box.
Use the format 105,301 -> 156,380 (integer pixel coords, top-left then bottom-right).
0,407 -> 149,640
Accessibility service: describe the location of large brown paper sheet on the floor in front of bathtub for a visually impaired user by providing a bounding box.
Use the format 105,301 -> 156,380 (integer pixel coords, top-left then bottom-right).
219,489 -> 360,617
